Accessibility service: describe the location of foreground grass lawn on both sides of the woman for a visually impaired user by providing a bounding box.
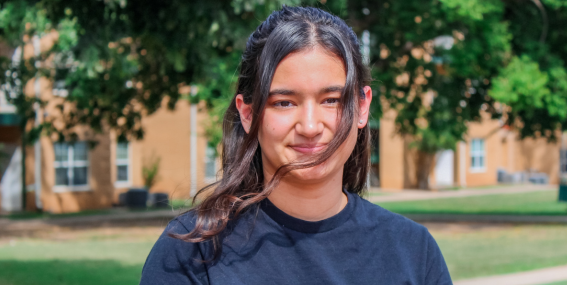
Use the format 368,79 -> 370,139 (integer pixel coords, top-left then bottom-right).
0,225 -> 567,285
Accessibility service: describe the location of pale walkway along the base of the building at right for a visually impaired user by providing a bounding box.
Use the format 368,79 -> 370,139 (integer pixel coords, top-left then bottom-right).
367,184 -> 558,203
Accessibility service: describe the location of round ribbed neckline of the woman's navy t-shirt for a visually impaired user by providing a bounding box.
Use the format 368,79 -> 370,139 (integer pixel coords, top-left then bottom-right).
260,191 -> 356,234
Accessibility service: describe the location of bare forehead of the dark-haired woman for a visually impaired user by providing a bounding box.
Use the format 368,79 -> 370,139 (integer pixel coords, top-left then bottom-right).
270,46 -> 346,94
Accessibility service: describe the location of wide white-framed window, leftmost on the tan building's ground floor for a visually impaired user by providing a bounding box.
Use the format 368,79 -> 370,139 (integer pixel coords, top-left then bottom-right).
54,142 -> 89,189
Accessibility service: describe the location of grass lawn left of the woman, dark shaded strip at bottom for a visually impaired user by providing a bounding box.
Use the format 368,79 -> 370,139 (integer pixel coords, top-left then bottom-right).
0,227 -> 159,285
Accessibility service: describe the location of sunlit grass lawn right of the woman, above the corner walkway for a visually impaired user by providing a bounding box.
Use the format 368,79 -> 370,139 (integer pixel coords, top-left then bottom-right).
430,225 -> 567,284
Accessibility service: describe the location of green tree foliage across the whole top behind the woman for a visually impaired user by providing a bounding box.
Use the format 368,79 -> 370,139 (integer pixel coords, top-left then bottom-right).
0,0 -> 567,192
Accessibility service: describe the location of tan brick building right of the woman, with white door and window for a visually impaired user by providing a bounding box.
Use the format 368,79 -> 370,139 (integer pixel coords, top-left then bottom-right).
374,107 -> 567,190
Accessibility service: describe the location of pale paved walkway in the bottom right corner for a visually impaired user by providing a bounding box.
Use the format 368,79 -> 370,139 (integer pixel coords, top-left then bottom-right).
454,265 -> 567,285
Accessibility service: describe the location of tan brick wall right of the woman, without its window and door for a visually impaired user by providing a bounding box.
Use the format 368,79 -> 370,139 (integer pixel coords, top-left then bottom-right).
380,110 -> 567,190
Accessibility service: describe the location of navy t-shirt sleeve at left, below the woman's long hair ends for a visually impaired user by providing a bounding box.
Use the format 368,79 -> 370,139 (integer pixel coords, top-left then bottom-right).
140,219 -> 209,285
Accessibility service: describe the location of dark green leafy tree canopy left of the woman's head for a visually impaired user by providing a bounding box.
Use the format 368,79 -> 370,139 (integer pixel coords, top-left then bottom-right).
0,0 -> 306,209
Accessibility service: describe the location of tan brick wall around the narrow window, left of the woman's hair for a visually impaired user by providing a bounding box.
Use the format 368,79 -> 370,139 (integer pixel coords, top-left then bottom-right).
111,99 -> 208,202
